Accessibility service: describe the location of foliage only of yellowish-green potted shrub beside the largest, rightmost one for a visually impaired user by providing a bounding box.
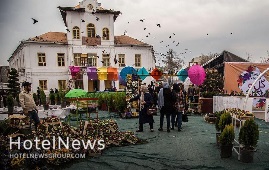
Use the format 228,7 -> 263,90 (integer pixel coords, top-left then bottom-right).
219,125 -> 235,145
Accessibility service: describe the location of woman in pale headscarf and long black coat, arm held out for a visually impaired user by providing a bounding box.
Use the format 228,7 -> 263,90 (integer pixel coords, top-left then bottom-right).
130,85 -> 154,132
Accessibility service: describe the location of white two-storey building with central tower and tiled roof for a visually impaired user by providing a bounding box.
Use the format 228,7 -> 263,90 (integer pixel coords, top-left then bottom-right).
8,0 -> 155,93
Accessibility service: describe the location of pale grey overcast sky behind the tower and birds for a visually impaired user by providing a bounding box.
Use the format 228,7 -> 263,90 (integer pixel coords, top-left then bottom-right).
0,0 -> 269,65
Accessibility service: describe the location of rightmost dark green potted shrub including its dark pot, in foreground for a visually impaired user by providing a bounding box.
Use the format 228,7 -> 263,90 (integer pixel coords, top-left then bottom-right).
239,119 -> 259,163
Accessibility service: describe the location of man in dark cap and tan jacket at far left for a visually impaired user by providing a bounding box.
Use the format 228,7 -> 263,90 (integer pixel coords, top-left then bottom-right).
19,82 -> 40,130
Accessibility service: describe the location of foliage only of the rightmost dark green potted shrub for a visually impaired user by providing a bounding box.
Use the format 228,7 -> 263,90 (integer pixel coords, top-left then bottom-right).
239,119 -> 259,149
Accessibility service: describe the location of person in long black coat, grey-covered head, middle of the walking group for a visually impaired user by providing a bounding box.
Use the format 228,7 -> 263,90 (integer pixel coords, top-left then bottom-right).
158,82 -> 175,132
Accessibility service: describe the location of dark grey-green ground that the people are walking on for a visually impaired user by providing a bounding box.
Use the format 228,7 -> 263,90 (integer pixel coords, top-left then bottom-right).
63,113 -> 269,170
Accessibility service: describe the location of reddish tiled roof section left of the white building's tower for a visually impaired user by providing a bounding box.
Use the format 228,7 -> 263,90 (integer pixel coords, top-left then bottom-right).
28,32 -> 67,43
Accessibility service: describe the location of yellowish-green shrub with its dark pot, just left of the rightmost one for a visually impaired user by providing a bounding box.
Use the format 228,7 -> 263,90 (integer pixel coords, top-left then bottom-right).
219,124 -> 235,158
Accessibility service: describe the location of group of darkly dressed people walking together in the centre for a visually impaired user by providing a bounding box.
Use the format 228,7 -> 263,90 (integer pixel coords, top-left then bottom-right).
130,82 -> 191,132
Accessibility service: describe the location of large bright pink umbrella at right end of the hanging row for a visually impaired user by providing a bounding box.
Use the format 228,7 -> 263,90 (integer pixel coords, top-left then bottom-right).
188,65 -> 206,86
